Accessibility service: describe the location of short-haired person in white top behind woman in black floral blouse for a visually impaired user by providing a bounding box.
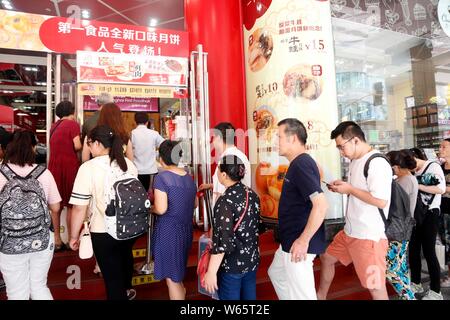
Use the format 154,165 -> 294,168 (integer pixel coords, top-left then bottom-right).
198,122 -> 252,205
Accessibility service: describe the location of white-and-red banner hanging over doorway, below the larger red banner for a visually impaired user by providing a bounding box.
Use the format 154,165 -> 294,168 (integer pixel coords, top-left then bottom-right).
77,51 -> 188,87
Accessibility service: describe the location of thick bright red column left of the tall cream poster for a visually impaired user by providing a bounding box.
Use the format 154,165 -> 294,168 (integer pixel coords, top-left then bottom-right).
185,0 -> 248,155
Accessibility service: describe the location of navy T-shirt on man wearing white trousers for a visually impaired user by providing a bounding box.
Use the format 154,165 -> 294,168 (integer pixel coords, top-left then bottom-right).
278,153 -> 326,254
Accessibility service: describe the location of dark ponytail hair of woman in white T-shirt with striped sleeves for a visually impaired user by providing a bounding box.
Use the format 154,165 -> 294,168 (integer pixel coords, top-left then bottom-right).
87,125 -> 128,172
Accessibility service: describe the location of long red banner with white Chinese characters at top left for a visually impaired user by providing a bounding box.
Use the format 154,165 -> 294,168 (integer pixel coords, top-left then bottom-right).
0,10 -> 189,57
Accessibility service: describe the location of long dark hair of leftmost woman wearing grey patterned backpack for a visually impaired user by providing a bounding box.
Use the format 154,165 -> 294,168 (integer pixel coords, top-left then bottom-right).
3,129 -> 37,167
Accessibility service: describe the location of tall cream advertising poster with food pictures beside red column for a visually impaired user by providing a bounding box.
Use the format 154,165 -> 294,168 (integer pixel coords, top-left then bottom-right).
244,0 -> 342,223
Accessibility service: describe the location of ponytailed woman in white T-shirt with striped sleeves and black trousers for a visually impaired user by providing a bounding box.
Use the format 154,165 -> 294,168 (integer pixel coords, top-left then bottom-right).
69,125 -> 137,300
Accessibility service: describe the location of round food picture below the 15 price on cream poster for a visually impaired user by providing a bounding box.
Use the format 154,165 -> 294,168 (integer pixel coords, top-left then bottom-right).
283,64 -> 323,100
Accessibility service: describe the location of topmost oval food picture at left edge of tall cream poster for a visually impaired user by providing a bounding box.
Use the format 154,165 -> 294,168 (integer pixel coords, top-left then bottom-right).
248,28 -> 273,72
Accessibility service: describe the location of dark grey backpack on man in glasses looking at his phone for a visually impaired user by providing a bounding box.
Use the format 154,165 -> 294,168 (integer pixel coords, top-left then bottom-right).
364,153 -> 415,241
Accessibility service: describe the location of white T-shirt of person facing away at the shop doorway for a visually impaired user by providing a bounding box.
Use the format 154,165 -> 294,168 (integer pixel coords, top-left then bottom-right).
131,125 -> 164,174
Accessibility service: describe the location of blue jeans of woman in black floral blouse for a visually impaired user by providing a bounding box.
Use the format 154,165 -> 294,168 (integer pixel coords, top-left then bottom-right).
217,270 -> 256,300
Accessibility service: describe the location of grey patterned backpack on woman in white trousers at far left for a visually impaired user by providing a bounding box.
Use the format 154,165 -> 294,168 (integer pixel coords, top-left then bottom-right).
0,165 -> 51,254
